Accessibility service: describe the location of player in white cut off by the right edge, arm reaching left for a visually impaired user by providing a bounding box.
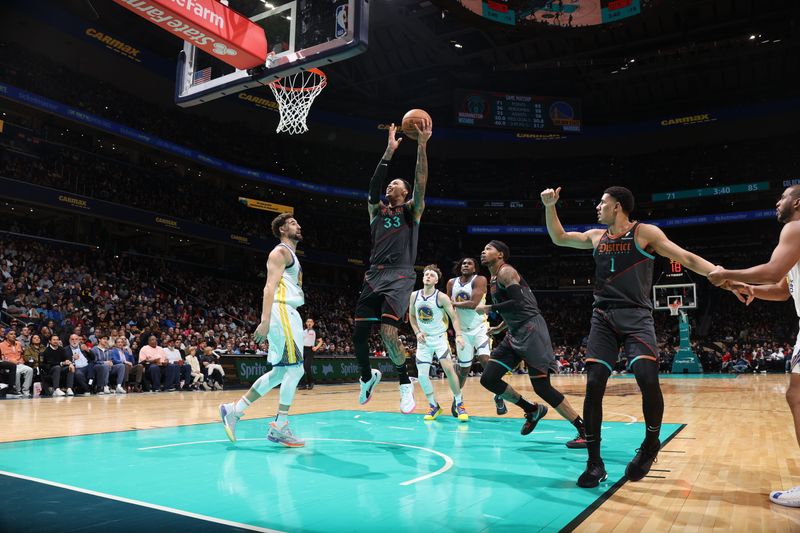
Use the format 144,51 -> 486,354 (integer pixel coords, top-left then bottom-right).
708,185 -> 800,507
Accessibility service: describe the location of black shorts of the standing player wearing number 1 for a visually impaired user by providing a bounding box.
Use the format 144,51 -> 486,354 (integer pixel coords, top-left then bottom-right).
586,307 -> 658,372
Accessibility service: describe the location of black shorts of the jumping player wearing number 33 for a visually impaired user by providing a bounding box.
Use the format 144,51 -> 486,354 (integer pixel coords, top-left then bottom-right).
356,268 -> 417,327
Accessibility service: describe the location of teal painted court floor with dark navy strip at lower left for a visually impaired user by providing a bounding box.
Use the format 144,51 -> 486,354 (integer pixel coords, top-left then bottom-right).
0,411 -> 683,532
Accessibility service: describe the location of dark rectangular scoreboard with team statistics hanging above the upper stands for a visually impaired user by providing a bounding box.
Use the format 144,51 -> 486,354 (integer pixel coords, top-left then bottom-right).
456,89 -> 581,133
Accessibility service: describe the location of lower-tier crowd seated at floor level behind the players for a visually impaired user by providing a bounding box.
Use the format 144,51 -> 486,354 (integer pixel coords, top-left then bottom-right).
0,231 -> 797,395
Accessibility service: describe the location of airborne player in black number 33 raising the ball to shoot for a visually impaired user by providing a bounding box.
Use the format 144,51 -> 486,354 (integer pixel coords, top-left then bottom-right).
353,119 -> 432,414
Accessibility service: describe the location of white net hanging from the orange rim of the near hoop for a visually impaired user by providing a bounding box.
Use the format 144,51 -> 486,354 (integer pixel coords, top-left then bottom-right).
269,68 -> 328,135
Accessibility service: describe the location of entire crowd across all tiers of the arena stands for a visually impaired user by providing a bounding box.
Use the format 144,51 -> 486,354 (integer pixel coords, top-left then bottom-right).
0,42 -> 798,400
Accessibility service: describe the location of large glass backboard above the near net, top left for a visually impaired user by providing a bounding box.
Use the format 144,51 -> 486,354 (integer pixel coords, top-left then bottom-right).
175,0 -> 369,107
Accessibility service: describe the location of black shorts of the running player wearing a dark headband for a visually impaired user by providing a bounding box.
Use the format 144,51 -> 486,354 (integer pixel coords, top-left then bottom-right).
491,315 -> 558,375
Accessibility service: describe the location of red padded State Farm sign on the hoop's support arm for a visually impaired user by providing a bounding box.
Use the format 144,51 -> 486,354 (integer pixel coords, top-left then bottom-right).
114,0 -> 267,69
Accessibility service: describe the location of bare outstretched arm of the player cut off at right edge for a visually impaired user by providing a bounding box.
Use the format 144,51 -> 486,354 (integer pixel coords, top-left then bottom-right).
708,221 -> 800,285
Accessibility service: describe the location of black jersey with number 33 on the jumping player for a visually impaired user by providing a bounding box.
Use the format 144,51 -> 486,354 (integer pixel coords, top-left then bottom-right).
369,203 -> 419,268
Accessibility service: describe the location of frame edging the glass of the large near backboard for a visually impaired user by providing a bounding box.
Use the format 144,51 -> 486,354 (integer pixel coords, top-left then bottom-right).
175,0 -> 369,107
